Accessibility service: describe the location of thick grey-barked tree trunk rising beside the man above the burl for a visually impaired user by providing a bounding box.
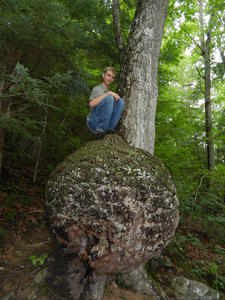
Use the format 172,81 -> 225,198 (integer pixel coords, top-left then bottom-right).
119,0 -> 168,154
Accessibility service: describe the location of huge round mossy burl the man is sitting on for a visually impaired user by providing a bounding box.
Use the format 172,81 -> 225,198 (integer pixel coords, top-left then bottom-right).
46,135 -> 178,300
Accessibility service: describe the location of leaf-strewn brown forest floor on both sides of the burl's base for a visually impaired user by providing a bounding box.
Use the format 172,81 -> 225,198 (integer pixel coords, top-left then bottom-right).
0,167 -> 225,300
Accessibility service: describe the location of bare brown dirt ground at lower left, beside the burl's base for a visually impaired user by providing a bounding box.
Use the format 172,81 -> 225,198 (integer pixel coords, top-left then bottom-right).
0,219 -> 156,300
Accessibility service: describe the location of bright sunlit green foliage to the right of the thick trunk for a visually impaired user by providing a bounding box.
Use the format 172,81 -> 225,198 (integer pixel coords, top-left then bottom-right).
156,1 -> 225,210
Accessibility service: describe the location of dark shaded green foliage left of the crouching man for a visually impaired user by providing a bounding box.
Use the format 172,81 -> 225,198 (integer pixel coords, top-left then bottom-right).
0,0 -> 124,178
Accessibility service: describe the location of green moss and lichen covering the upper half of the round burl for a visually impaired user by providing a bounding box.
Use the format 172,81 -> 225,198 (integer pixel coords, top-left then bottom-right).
46,135 -> 178,230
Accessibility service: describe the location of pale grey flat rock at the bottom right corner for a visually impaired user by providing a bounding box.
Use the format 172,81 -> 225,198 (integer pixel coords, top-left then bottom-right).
172,277 -> 220,300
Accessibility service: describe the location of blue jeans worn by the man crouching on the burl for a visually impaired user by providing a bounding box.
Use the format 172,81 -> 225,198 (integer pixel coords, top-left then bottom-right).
87,95 -> 124,133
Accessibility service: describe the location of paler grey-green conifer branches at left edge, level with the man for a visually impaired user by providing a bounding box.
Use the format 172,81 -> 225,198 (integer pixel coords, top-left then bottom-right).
0,63 -> 71,145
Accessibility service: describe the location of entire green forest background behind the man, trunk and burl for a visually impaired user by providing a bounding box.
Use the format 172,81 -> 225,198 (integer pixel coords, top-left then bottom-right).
0,0 -> 225,291
